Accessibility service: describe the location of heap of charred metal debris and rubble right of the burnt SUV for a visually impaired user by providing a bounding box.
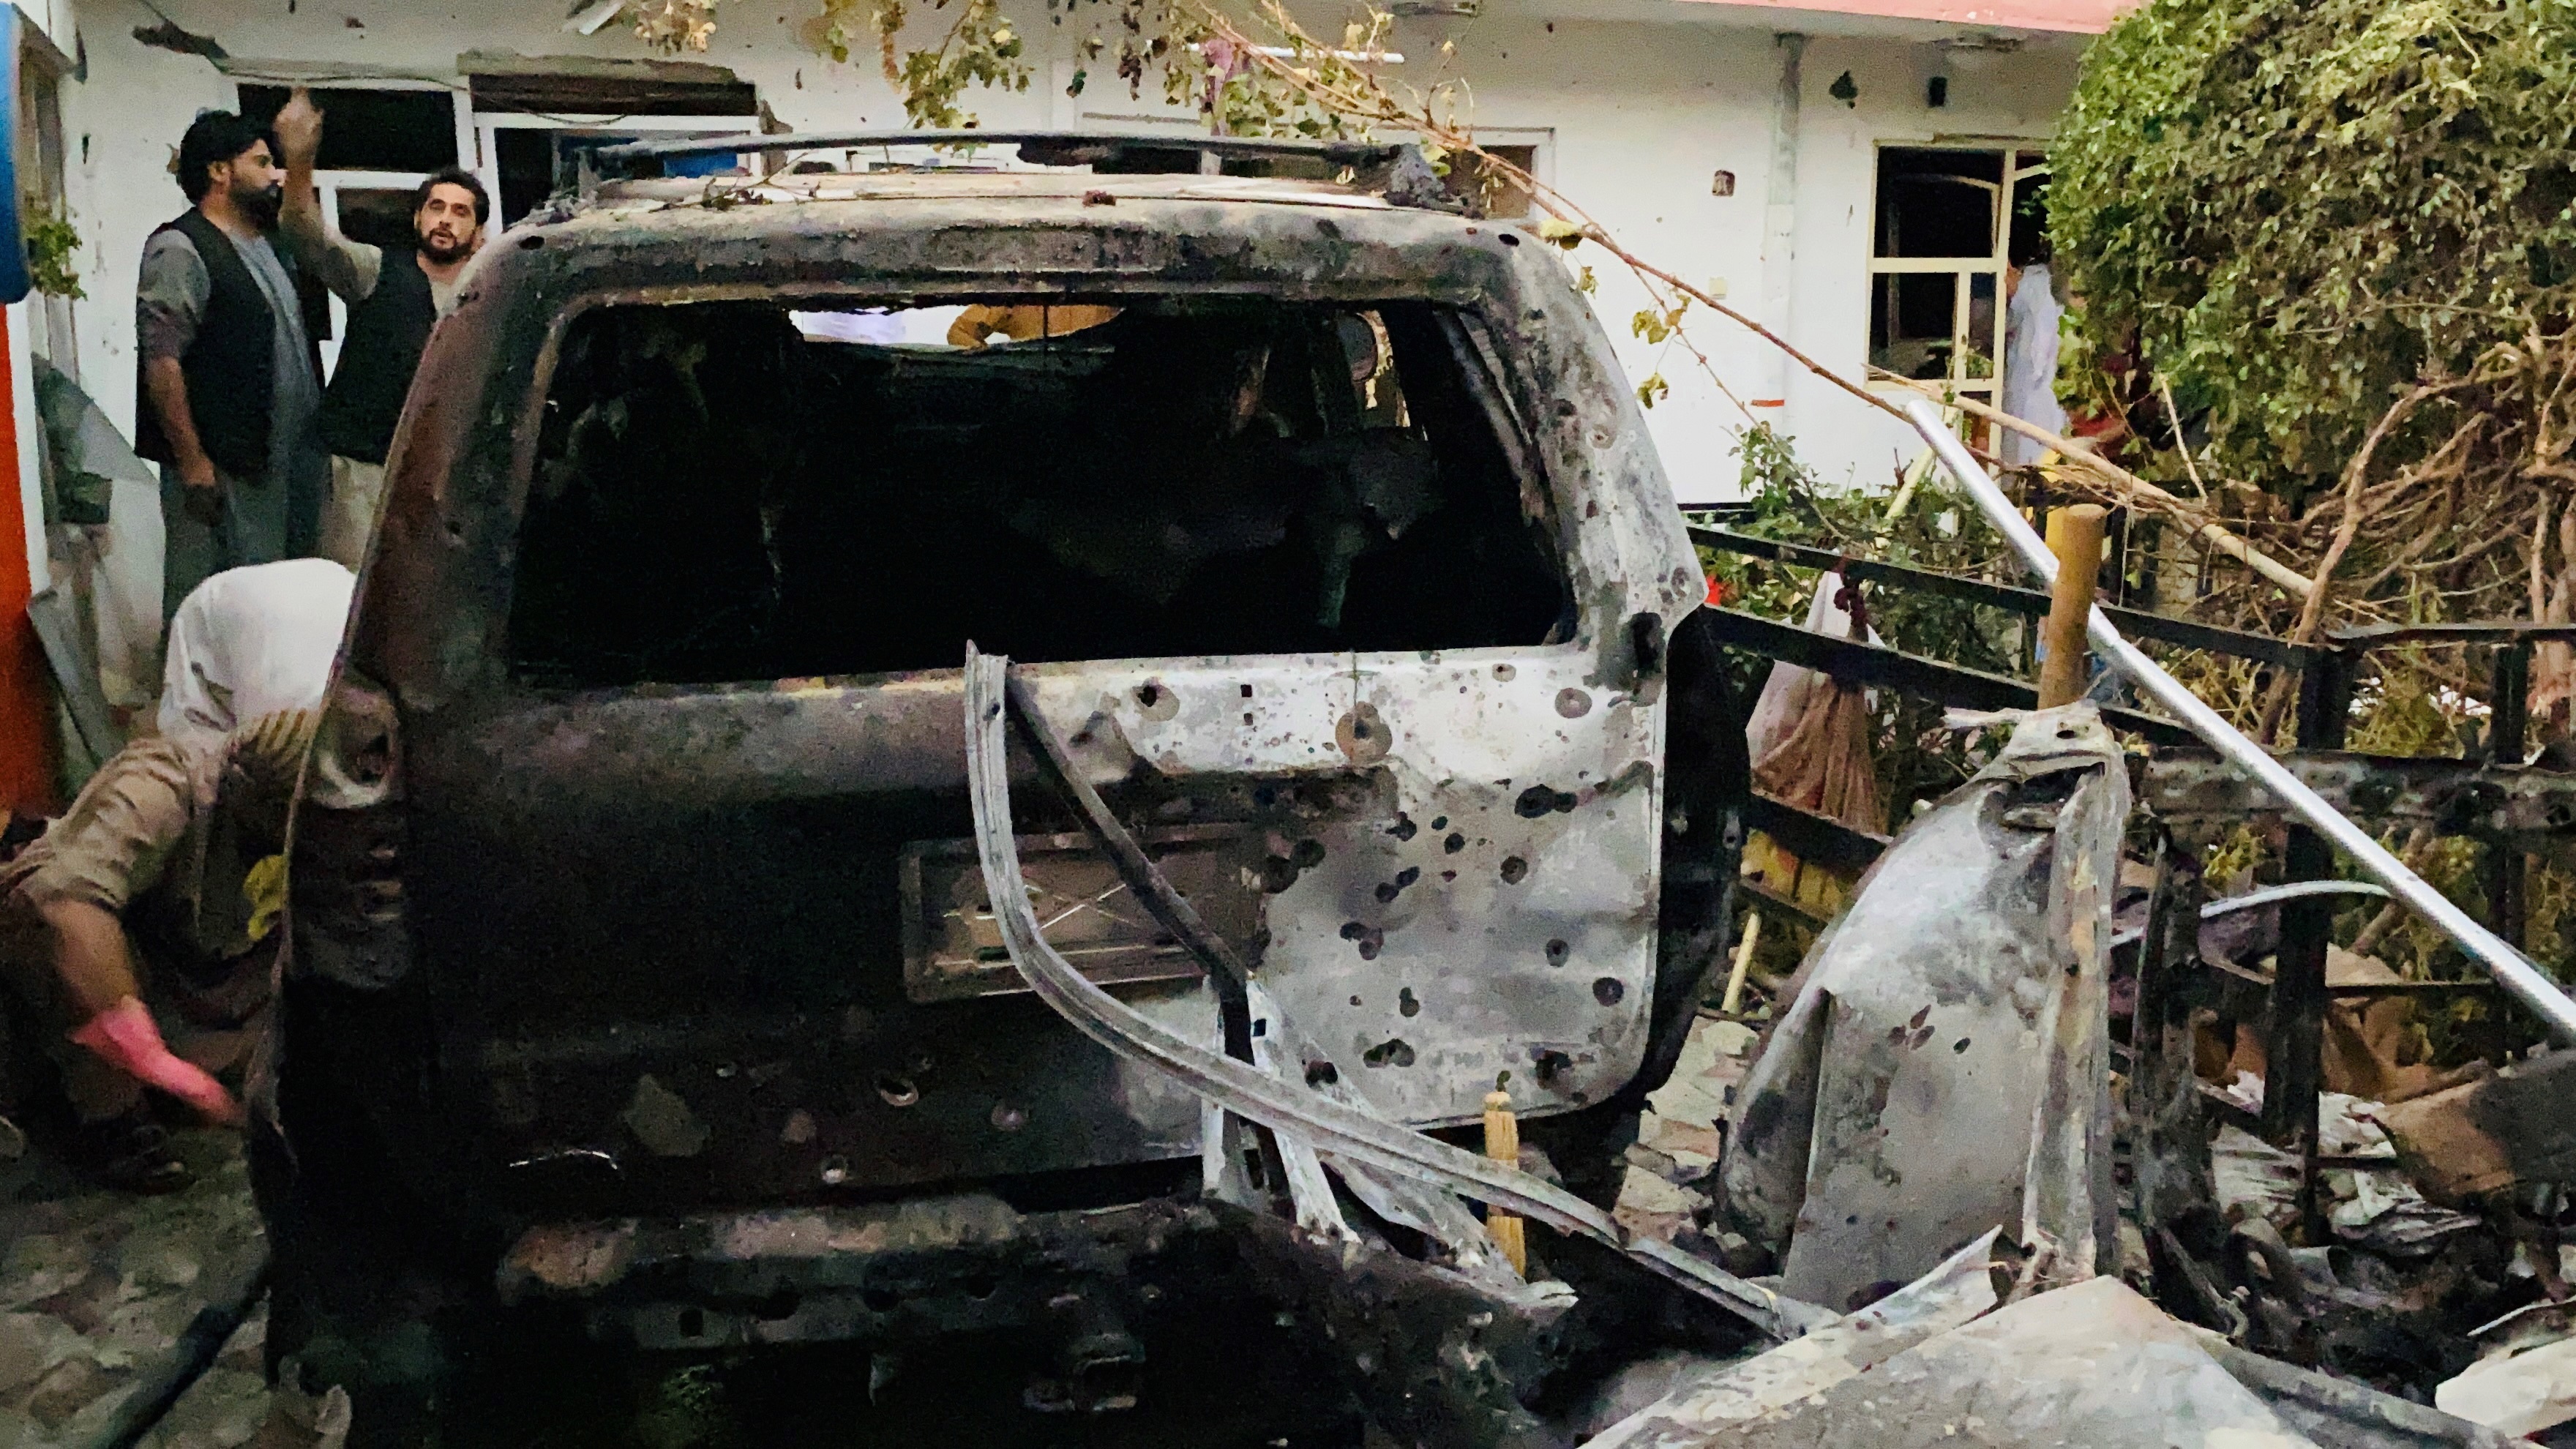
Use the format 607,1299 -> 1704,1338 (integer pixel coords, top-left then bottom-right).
1592,706 -> 2576,1446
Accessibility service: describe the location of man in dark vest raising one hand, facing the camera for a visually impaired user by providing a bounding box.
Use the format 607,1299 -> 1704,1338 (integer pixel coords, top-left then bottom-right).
276,85 -> 492,570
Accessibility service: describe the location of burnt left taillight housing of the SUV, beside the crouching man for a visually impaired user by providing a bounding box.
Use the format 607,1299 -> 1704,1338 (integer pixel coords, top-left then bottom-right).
288,667 -> 412,987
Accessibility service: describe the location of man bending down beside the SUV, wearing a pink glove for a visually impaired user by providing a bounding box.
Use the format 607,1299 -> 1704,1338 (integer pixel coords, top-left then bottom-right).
0,560 -> 353,1191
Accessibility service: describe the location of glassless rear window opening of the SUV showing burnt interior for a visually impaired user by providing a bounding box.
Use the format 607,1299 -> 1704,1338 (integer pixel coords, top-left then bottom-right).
510,296 -> 1571,689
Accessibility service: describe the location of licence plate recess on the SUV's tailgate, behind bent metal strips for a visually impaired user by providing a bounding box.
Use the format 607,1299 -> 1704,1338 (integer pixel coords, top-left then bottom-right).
902,825 -> 1262,1003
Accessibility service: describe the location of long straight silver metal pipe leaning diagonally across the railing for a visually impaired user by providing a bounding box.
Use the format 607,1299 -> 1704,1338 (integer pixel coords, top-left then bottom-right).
1906,400 -> 2576,1044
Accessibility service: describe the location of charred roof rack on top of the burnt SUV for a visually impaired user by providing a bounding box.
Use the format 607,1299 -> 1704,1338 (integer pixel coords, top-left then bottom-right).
577,132 -> 1468,211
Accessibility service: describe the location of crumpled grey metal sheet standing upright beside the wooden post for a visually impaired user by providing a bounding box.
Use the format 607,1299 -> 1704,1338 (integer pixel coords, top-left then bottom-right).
1718,704 -> 2128,1307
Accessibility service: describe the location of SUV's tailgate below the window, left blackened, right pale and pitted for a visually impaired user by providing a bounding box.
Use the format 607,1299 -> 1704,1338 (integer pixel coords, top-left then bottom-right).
405,645 -> 1664,1202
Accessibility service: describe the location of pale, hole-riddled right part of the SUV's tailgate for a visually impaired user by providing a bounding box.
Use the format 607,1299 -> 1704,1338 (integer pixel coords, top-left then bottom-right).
1017,647 -> 1664,1124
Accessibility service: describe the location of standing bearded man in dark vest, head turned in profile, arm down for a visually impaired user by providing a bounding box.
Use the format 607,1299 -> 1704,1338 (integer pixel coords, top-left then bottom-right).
134,111 -> 330,616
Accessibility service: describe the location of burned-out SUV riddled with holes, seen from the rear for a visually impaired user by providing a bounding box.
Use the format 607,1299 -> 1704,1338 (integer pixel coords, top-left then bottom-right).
268,137 -> 1742,1423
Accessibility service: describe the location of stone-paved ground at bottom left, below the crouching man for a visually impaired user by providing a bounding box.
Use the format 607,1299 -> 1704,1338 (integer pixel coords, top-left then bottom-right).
0,1132 -> 268,1449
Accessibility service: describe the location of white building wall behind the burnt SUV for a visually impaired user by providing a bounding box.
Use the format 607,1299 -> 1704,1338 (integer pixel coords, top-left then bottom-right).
49,0 -> 2076,503
